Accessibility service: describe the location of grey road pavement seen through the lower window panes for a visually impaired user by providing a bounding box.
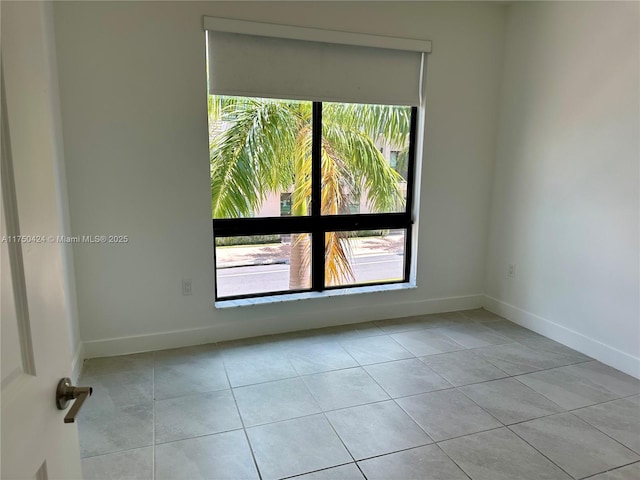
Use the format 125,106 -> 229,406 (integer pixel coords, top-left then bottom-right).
217,254 -> 404,297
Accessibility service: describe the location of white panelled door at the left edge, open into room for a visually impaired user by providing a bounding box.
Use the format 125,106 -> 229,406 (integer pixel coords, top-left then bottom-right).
0,1 -> 84,480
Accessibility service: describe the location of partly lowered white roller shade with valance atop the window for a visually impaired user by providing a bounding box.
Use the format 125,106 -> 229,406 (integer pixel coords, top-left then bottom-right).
204,17 -> 431,106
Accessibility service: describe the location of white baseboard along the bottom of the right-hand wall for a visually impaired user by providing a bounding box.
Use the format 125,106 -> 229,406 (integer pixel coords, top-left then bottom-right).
484,295 -> 640,378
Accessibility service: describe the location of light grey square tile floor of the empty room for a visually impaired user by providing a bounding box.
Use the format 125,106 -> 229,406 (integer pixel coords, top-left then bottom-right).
78,310 -> 640,480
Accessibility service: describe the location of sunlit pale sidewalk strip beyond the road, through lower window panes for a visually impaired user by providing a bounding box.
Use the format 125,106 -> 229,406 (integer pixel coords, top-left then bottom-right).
216,235 -> 404,268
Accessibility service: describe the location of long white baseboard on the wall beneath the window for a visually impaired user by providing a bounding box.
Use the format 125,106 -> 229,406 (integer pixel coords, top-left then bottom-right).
83,294 -> 484,358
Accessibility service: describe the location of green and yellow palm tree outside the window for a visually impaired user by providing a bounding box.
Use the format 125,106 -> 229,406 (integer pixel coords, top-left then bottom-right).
209,95 -> 410,289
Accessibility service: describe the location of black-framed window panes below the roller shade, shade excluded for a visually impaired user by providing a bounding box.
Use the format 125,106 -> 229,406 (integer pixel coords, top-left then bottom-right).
209,96 -> 416,299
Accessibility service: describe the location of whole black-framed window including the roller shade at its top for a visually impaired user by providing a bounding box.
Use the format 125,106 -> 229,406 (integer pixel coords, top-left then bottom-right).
205,18 -> 428,300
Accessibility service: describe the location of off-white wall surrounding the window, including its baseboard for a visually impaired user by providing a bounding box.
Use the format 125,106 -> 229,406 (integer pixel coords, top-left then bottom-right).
54,2 -> 505,356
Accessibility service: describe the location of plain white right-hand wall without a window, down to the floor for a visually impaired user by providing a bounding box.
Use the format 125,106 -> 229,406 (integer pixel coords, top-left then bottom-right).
486,2 -> 640,376
